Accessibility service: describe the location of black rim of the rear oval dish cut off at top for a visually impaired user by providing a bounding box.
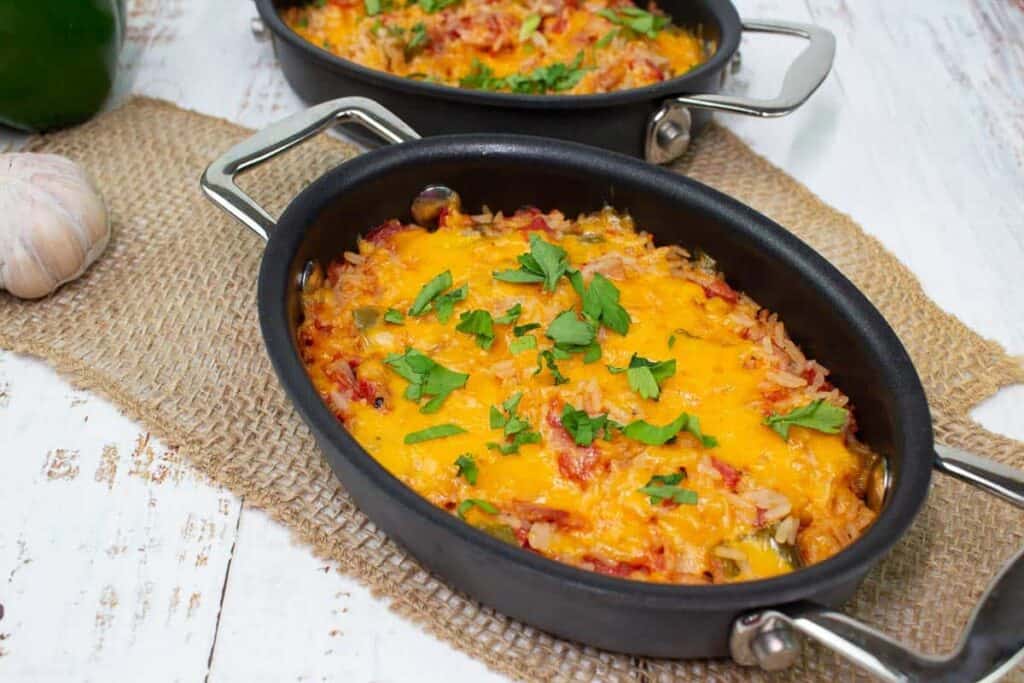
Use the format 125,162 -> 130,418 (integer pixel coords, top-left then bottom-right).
256,0 -> 742,110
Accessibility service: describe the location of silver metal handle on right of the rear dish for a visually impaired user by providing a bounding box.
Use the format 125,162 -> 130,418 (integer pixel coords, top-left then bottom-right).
644,19 -> 836,164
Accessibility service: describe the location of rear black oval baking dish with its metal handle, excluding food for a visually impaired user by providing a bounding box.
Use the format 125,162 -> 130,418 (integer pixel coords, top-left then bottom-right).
256,0 -> 836,164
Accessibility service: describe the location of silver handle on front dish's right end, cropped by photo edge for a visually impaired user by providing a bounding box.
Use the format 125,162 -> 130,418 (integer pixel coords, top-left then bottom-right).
729,445 -> 1024,682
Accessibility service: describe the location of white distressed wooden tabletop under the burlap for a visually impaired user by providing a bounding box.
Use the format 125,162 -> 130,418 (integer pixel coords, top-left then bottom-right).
0,0 -> 1024,683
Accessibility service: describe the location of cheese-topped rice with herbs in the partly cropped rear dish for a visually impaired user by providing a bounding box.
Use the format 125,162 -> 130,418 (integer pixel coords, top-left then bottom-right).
283,0 -> 706,94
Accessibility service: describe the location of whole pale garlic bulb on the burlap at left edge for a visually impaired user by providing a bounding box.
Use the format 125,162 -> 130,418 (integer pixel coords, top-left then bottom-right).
0,154 -> 111,299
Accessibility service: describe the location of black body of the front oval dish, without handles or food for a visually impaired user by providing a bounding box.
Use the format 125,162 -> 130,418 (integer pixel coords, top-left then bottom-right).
260,136 -> 932,656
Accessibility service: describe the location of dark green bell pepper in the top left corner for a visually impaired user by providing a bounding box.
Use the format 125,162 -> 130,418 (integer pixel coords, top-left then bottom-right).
0,0 -> 126,131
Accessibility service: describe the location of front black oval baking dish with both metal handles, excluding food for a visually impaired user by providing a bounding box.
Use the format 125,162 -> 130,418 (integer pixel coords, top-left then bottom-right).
202,98 -> 1024,680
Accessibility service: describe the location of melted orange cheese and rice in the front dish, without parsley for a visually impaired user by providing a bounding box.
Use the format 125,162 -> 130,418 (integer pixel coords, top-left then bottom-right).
299,204 -> 874,584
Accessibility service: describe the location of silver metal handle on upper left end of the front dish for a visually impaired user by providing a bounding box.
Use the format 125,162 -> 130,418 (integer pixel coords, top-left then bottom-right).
200,97 -> 420,240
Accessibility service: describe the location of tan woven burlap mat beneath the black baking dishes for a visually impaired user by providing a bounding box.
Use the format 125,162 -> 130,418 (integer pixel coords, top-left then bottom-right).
0,99 -> 1024,681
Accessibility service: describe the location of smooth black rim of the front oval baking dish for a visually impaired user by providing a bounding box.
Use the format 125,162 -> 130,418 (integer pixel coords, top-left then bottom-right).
258,134 -> 934,611
